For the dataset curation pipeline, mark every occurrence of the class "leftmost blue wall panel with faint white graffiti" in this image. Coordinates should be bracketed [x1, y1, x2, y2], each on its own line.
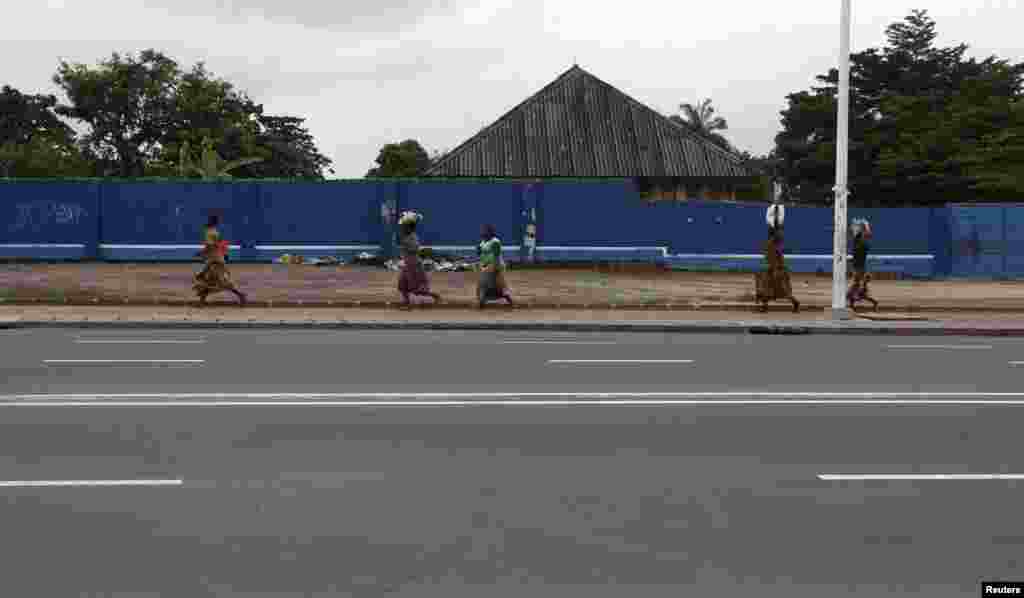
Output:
[0, 182, 99, 259]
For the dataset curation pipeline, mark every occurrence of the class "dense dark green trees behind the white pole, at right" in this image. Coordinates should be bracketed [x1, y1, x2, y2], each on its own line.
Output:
[773, 10, 1024, 205]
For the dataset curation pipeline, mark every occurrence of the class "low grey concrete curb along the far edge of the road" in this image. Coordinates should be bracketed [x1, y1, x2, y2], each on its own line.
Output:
[0, 319, 1024, 337]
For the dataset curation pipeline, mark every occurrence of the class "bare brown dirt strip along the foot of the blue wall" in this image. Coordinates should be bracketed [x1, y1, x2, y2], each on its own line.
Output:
[6, 264, 1024, 317]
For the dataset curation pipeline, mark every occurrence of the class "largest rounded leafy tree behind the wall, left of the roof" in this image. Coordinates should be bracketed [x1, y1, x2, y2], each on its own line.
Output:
[54, 49, 333, 178]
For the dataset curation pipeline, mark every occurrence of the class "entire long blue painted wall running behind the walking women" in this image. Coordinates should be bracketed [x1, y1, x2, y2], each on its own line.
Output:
[0, 180, 1024, 277]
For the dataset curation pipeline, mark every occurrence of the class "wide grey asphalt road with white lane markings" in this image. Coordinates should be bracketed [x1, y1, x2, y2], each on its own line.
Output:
[0, 330, 1024, 598]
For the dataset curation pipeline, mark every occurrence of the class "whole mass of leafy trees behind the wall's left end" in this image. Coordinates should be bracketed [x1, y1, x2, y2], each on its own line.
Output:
[0, 49, 334, 178]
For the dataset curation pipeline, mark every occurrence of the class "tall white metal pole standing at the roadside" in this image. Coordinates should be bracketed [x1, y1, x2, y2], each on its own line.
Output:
[831, 0, 850, 319]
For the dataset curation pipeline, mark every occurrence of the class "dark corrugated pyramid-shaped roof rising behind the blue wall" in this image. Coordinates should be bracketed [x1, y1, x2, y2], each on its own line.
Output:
[426, 67, 752, 178]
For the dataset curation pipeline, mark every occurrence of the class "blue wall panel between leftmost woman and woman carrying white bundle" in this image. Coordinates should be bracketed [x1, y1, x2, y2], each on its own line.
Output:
[254, 181, 387, 261]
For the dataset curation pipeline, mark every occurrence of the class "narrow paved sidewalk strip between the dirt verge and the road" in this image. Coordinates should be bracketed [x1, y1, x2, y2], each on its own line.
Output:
[0, 306, 1024, 336]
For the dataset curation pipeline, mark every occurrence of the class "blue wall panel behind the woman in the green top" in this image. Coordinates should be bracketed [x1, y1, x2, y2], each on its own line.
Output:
[399, 182, 524, 249]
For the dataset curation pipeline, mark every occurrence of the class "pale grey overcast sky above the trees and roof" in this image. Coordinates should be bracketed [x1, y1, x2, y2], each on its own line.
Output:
[0, 0, 1024, 178]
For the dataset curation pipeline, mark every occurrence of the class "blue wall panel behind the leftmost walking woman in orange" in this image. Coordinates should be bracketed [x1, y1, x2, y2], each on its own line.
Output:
[100, 182, 256, 261]
